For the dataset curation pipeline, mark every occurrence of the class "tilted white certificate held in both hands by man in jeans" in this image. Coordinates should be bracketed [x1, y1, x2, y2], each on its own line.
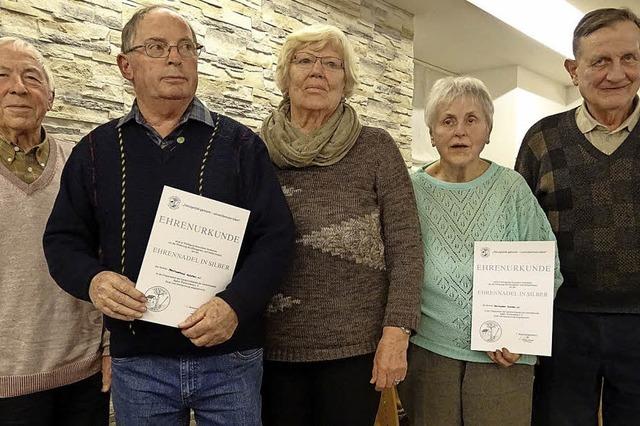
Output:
[136, 186, 249, 327]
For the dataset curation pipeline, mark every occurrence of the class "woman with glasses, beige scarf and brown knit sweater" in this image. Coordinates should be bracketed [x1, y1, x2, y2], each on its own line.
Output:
[262, 25, 422, 426]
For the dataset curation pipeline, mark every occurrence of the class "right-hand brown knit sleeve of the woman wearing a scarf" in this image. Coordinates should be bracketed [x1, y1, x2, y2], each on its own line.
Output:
[376, 131, 424, 330]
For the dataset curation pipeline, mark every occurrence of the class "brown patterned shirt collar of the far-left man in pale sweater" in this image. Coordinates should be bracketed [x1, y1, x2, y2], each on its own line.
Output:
[0, 128, 49, 184]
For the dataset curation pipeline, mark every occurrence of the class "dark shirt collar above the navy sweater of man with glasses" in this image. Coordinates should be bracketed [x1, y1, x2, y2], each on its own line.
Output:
[117, 97, 213, 149]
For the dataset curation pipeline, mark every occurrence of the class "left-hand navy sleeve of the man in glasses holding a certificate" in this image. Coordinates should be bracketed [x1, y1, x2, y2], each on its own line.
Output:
[43, 140, 107, 301]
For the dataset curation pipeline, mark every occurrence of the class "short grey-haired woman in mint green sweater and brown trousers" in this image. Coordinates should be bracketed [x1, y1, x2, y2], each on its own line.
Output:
[399, 77, 562, 426]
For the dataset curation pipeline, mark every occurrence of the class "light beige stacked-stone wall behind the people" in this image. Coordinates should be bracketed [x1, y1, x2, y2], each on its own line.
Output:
[0, 0, 413, 161]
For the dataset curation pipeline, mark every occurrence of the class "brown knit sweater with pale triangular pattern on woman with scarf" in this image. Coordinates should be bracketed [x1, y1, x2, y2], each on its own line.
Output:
[265, 127, 423, 362]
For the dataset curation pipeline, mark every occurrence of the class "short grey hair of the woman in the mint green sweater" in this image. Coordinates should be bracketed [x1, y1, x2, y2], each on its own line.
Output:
[424, 76, 493, 131]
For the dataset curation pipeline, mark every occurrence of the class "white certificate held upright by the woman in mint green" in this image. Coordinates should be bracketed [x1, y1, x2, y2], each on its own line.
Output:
[471, 241, 556, 356]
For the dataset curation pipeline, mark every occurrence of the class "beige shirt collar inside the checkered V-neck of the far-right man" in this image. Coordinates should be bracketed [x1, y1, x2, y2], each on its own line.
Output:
[576, 96, 640, 155]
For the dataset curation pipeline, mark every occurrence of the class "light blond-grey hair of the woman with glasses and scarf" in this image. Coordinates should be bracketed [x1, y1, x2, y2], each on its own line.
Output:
[276, 24, 359, 97]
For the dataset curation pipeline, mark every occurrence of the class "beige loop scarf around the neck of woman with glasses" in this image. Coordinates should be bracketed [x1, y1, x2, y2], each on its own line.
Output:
[261, 98, 362, 168]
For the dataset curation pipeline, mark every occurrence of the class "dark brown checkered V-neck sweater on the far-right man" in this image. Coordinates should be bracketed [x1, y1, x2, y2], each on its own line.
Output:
[515, 109, 640, 314]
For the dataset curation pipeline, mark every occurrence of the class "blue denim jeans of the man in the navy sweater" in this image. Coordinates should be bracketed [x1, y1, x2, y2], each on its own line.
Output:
[111, 349, 262, 426]
